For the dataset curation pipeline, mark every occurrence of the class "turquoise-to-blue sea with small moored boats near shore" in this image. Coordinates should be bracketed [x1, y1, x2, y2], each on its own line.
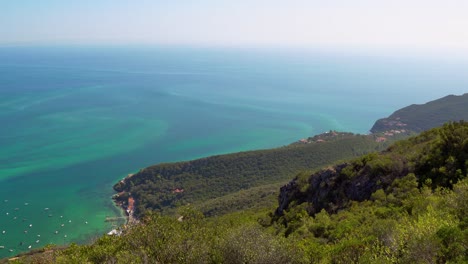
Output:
[0, 47, 468, 258]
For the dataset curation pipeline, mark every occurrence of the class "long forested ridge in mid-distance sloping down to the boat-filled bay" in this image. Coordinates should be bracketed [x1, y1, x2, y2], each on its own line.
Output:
[114, 131, 388, 216]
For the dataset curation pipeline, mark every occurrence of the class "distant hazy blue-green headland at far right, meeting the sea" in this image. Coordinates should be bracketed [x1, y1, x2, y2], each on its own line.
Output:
[371, 93, 468, 133]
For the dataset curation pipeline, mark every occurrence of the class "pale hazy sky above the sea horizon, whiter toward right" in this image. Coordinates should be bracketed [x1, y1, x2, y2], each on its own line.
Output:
[0, 0, 468, 53]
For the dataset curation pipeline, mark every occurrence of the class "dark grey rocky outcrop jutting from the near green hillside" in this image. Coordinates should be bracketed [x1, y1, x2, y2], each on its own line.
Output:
[276, 161, 409, 216]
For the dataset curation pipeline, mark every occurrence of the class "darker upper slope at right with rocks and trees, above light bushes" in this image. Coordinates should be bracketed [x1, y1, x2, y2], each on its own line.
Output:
[276, 121, 468, 218]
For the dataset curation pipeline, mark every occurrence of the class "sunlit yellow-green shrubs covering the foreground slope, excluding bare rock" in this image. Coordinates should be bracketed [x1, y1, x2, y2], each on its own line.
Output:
[9, 122, 468, 263]
